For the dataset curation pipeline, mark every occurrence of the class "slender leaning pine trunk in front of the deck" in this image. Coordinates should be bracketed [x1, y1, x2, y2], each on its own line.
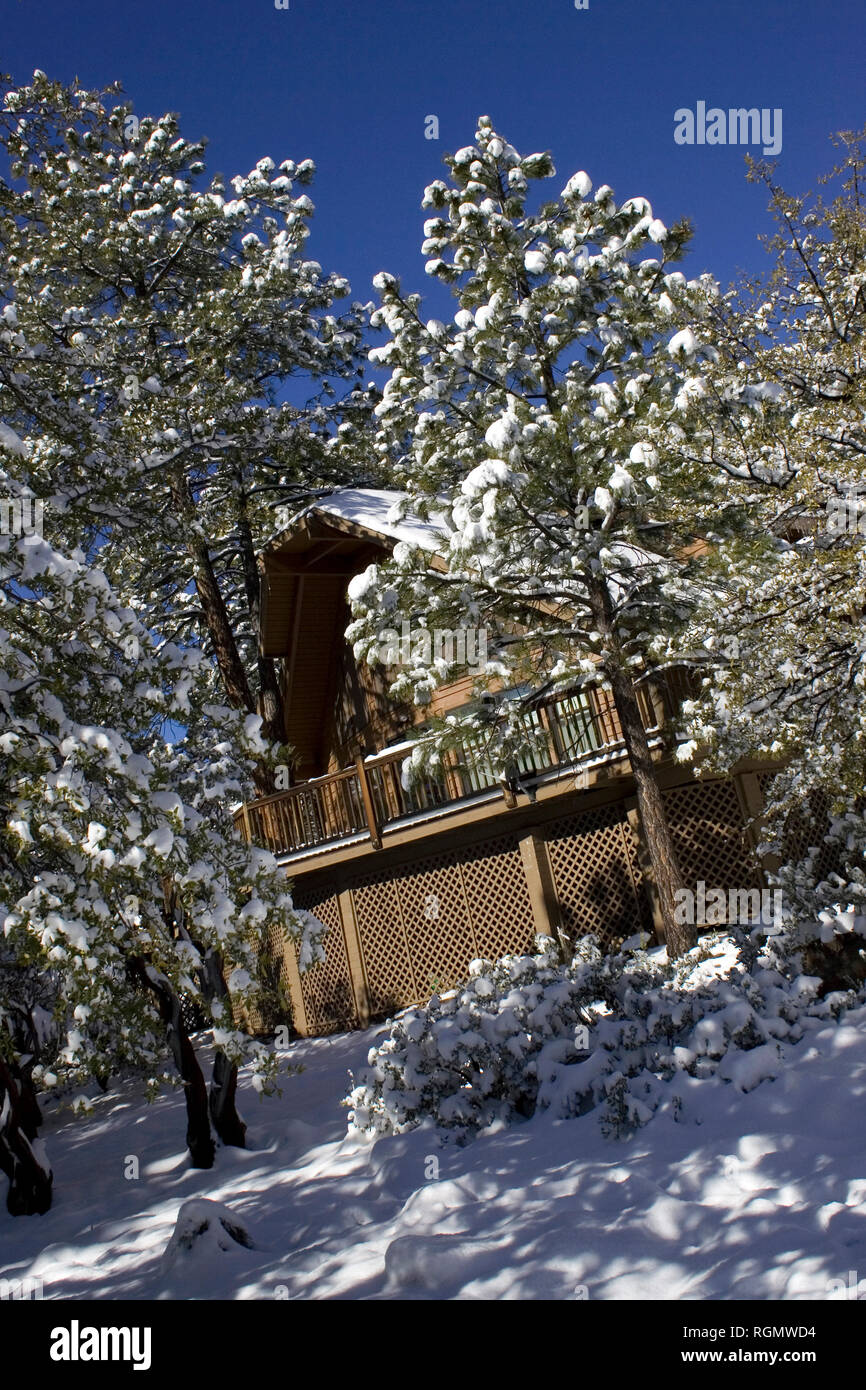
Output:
[589, 584, 695, 958]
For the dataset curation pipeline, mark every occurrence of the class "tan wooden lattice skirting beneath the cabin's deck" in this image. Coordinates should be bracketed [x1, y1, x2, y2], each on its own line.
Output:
[261, 781, 778, 1034]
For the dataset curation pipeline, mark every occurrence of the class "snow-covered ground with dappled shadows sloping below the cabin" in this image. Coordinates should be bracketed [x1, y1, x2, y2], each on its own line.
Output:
[0, 1009, 866, 1300]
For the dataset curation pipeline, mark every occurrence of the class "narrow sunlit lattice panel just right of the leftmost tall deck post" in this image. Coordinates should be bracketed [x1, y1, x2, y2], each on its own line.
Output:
[352, 874, 421, 1013]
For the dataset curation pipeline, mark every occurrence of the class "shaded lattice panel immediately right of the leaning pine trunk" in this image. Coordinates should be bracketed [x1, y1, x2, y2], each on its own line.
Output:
[664, 781, 760, 888]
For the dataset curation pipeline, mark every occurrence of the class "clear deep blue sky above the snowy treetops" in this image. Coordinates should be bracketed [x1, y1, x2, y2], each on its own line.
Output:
[0, 0, 866, 309]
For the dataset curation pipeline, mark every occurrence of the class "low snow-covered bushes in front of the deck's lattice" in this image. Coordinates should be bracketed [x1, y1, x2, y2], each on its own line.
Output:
[345, 917, 866, 1140]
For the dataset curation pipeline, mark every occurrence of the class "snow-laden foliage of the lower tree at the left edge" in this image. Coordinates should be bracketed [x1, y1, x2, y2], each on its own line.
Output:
[0, 511, 321, 1087]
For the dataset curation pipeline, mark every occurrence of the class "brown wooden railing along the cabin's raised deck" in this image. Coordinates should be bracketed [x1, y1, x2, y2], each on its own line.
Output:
[235, 666, 706, 853]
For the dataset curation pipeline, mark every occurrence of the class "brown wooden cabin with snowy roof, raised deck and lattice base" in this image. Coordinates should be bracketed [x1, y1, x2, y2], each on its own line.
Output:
[236, 489, 771, 1034]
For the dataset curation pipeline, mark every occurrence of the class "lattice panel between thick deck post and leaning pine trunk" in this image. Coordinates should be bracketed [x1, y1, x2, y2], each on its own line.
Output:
[548, 805, 652, 947]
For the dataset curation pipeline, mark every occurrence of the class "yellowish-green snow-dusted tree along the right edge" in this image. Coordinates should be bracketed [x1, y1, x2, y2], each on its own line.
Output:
[675, 132, 866, 923]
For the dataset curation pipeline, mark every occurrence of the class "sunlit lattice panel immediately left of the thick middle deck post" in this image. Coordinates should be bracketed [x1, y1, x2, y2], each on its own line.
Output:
[460, 838, 535, 960]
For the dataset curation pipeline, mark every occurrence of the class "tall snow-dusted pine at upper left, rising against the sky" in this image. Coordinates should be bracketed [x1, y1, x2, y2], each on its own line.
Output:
[0, 72, 366, 794]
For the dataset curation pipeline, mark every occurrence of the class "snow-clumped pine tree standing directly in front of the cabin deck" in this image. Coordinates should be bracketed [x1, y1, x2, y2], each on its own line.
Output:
[350, 117, 740, 954]
